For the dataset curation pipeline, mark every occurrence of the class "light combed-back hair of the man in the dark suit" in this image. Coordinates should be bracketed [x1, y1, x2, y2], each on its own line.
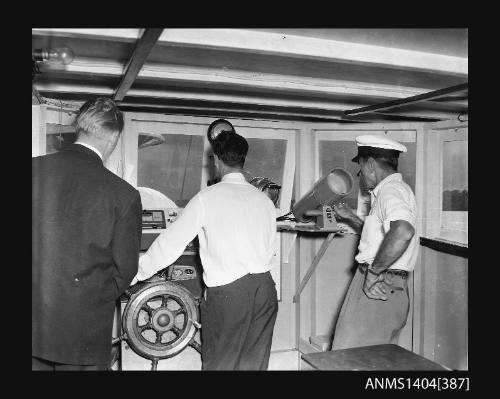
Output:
[73, 97, 123, 137]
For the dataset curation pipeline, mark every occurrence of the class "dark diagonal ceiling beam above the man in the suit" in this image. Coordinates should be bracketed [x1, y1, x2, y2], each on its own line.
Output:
[113, 28, 163, 101]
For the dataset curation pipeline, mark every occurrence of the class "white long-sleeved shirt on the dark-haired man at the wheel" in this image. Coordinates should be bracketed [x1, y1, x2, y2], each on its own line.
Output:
[134, 173, 277, 287]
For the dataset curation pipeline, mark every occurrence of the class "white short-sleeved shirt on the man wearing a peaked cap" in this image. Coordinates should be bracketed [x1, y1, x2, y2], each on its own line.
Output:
[355, 173, 418, 271]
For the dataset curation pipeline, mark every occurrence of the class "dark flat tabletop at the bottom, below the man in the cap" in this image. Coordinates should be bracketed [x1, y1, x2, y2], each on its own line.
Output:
[302, 344, 447, 371]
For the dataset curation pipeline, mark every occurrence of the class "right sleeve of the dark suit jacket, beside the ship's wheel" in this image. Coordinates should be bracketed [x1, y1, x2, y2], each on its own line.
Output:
[112, 191, 142, 298]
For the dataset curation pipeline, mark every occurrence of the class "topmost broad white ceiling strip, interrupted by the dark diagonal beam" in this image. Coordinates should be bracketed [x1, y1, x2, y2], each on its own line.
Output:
[32, 29, 468, 77]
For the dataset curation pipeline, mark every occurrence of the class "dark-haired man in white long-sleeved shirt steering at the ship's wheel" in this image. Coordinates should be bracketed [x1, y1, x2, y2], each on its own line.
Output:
[134, 132, 278, 370]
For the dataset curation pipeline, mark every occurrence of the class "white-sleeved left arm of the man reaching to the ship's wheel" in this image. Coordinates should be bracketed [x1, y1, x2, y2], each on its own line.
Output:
[131, 195, 203, 285]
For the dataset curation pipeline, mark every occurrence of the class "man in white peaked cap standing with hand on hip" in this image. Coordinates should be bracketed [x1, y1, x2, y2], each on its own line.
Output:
[332, 135, 418, 350]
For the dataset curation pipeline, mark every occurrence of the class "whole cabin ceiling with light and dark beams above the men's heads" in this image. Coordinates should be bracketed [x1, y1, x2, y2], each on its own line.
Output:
[32, 29, 468, 122]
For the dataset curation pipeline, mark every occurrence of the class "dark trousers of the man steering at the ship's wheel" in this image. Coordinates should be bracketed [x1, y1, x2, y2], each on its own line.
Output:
[201, 272, 278, 370]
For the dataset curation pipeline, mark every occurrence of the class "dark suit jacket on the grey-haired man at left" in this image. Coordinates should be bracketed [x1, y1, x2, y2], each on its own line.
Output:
[32, 144, 142, 364]
